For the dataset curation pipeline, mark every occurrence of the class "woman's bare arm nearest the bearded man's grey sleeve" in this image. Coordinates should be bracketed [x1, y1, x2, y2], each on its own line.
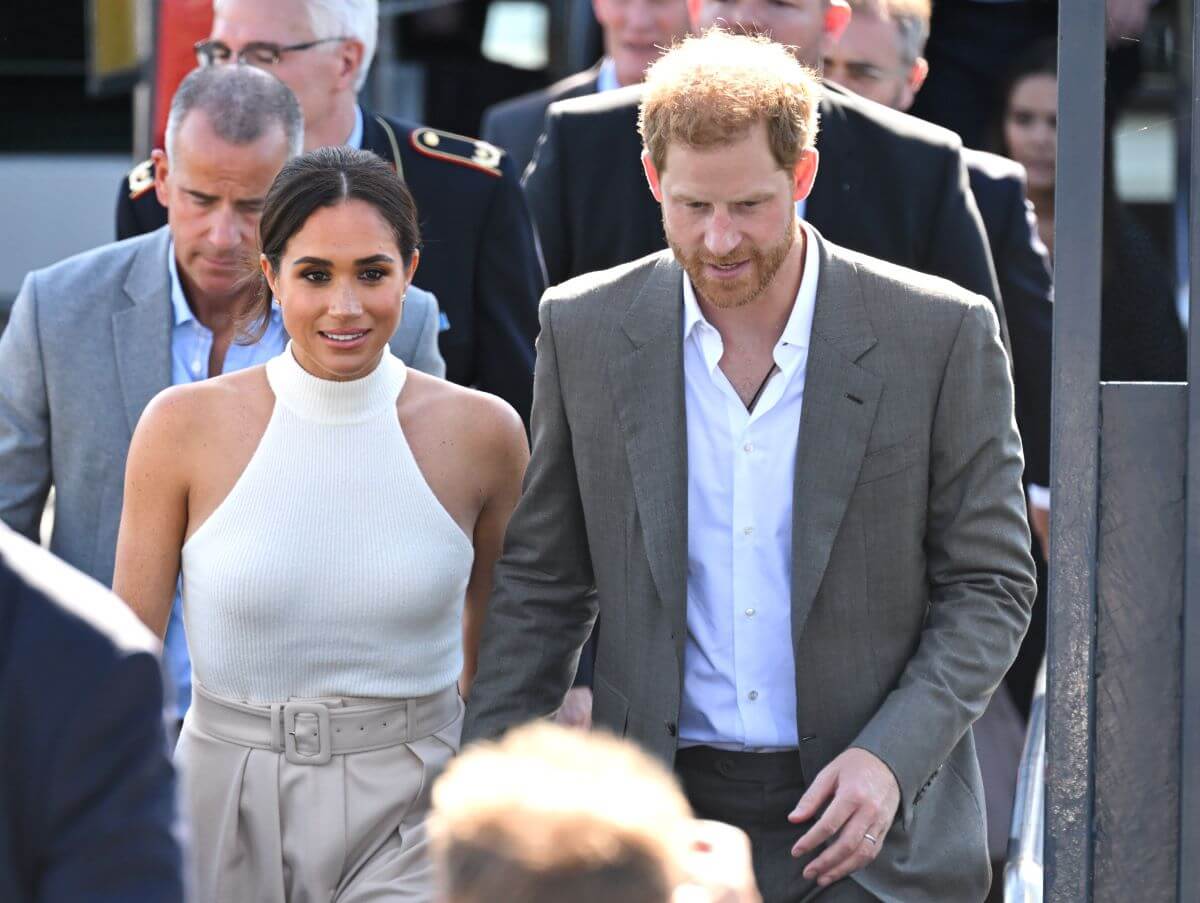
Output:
[458, 400, 529, 699]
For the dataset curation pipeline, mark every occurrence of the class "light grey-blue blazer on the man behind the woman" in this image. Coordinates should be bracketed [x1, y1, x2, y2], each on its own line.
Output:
[0, 226, 445, 585]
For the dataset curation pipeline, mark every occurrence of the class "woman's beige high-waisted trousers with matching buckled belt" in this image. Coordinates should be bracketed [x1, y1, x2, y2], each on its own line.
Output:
[175, 684, 463, 903]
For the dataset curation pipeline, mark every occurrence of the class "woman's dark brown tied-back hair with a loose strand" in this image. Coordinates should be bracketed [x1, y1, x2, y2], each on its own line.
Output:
[240, 146, 421, 342]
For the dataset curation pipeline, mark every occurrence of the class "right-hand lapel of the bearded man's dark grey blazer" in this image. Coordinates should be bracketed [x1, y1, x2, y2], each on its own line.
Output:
[792, 235, 883, 644]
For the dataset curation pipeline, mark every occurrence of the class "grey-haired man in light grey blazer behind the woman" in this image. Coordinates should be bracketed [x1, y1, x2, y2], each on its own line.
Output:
[0, 66, 445, 718]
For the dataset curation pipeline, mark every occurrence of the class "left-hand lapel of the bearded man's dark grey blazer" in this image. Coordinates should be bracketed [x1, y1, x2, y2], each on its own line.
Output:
[608, 251, 688, 662]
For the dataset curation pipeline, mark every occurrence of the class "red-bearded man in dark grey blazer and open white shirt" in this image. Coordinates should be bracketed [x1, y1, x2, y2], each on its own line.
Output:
[464, 30, 1033, 903]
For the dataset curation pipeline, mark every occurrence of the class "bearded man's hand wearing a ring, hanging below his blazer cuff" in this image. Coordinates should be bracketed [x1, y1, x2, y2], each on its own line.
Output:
[787, 748, 900, 887]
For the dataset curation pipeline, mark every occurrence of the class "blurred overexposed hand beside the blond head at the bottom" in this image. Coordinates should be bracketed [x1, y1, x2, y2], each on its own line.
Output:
[672, 819, 762, 903]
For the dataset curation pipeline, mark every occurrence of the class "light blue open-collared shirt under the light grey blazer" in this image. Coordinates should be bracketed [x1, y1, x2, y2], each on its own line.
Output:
[162, 243, 288, 718]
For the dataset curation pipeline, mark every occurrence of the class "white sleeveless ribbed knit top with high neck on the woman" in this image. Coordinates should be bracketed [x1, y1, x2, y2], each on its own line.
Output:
[182, 343, 474, 702]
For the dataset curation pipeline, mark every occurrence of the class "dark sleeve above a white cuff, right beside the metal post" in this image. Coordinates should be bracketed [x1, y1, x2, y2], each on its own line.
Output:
[992, 183, 1054, 486]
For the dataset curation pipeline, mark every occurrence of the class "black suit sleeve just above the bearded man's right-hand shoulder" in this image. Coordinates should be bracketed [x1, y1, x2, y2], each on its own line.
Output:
[917, 149, 1009, 349]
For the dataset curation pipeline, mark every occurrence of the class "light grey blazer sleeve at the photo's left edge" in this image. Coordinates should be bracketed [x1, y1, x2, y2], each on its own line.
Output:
[0, 273, 52, 542]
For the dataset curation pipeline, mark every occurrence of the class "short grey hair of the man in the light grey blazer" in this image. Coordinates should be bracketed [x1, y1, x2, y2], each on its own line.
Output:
[166, 66, 304, 157]
